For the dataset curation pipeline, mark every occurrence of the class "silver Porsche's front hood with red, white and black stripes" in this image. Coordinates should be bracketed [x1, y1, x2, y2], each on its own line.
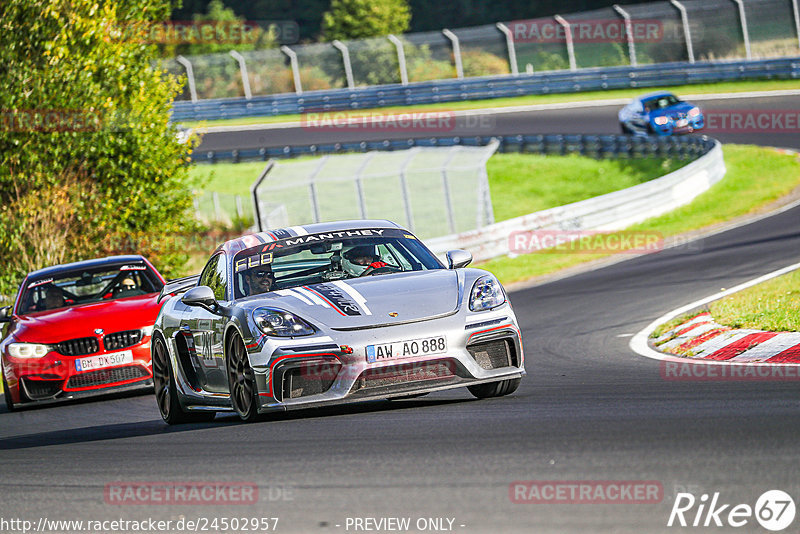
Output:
[243, 269, 461, 329]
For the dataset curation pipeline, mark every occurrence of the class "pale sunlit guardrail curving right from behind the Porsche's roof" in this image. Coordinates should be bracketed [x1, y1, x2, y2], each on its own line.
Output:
[426, 139, 726, 261]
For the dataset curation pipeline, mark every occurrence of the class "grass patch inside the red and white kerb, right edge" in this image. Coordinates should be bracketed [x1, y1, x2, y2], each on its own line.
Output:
[708, 271, 800, 332]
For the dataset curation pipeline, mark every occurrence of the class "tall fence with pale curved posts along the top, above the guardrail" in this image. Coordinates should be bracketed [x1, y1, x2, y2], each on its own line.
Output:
[164, 0, 800, 100]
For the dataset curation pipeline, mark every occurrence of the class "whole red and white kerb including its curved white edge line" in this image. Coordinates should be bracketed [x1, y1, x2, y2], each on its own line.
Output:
[629, 263, 800, 366]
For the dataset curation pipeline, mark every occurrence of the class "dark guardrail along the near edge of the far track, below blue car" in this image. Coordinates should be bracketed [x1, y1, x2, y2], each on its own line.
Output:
[192, 134, 713, 163]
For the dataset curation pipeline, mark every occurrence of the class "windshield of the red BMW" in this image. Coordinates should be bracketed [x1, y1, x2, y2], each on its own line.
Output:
[19, 262, 163, 314]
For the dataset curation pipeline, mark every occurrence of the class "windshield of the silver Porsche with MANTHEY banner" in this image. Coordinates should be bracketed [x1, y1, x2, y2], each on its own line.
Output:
[233, 228, 444, 298]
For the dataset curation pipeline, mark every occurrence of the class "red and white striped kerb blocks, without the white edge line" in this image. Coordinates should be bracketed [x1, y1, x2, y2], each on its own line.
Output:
[654, 312, 800, 363]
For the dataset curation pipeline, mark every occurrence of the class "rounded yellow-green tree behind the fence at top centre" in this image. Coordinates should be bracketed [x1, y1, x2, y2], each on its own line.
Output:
[322, 0, 411, 41]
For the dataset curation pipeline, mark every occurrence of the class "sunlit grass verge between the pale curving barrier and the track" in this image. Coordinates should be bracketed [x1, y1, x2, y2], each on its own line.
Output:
[481, 145, 800, 284]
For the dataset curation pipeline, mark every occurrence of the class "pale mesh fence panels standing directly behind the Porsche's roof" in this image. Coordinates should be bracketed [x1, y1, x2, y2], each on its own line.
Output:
[253, 144, 499, 238]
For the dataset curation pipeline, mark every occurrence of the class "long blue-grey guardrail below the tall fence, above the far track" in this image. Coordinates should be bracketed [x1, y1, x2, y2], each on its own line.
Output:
[172, 57, 800, 122]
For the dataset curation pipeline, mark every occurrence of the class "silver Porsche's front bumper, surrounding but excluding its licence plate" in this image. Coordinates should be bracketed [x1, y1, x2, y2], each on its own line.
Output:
[250, 310, 525, 412]
